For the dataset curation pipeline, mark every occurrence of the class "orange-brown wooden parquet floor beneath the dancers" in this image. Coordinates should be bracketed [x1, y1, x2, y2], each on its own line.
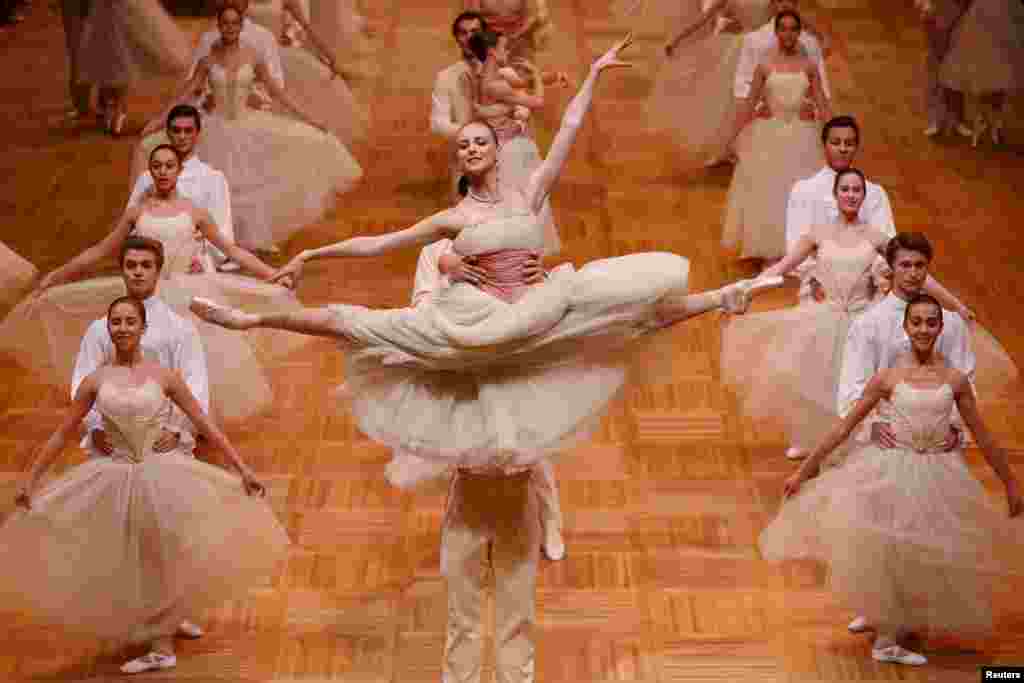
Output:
[0, 0, 1024, 683]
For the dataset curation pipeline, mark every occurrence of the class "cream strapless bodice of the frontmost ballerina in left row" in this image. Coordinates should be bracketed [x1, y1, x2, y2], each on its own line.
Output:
[96, 380, 171, 463]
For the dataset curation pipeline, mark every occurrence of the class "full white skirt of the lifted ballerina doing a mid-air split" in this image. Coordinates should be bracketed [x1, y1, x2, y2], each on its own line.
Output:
[331, 253, 689, 485]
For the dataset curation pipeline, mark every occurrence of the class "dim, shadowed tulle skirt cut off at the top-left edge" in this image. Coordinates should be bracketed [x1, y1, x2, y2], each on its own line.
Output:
[79, 0, 191, 86]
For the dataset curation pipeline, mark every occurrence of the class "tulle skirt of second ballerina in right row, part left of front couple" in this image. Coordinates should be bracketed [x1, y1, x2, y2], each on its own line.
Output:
[722, 303, 855, 447]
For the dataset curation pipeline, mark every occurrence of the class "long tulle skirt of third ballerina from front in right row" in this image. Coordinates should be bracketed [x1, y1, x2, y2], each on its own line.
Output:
[722, 118, 824, 259]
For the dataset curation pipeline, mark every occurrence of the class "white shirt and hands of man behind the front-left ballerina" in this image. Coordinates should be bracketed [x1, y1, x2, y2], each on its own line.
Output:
[71, 294, 210, 456]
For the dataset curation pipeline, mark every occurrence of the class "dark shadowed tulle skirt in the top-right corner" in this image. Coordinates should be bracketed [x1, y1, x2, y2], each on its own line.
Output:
[939, 0, 1024, 95]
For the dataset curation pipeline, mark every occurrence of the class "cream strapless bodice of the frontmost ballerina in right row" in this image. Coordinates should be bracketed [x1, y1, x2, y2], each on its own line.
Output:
[888, 382, 954, 453]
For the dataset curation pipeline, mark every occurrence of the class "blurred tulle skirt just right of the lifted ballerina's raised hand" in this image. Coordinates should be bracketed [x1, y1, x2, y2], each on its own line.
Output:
[648, 34, 743, 163]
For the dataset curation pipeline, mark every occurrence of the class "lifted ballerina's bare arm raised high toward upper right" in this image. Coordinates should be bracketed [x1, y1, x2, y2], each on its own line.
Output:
[525, 33, 633, 213]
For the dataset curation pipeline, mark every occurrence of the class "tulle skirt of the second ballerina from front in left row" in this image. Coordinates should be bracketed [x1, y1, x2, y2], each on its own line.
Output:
[0, 273, 308, 422]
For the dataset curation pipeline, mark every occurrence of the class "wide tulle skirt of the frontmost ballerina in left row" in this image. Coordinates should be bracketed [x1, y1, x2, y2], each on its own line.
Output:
[0, 452, 290, 642]
